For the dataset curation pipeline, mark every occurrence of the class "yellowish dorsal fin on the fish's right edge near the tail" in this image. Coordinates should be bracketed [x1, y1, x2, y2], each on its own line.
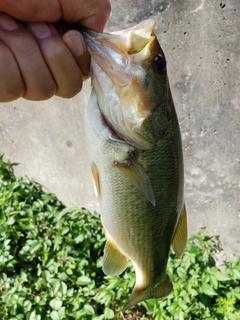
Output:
[172, 205, 187, 257]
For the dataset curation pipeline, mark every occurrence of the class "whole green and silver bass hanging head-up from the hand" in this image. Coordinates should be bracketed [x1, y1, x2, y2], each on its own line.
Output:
[82, 19, 187, 311]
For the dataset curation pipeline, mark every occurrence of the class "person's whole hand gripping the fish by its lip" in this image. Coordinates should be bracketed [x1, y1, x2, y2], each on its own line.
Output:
[0, 0, 110, 102]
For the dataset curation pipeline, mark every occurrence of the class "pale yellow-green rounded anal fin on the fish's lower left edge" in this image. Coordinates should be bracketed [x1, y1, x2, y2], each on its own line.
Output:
[103, 238, 128, 275]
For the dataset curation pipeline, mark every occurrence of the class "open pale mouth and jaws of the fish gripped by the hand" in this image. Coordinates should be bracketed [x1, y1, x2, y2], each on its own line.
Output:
[82, 19, 155, 86]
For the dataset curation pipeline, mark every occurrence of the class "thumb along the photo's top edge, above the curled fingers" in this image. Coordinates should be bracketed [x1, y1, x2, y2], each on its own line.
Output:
[0, 0, 111, 32]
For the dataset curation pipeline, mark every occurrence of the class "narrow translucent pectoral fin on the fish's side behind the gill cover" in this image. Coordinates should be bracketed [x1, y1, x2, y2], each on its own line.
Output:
[115, 154, 156, 206]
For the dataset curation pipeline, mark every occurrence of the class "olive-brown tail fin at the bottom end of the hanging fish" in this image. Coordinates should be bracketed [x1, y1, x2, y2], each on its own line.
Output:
[123, 275, 172, 311]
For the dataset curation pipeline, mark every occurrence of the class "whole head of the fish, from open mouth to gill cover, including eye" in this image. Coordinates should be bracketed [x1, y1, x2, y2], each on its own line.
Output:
[83, 19, 170, 150]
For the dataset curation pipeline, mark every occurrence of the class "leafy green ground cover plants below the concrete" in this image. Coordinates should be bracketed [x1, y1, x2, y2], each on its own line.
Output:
[0, 158, 240, 320]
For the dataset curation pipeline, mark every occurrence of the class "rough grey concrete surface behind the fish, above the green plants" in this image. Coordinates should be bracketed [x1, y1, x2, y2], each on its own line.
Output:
[0, 0, 240, 258]
